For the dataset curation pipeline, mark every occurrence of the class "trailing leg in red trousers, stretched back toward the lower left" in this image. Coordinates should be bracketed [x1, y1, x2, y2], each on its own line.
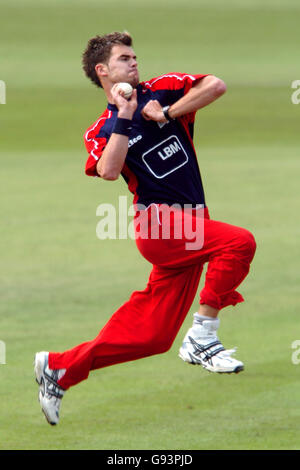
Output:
[45, 264, 202, 390]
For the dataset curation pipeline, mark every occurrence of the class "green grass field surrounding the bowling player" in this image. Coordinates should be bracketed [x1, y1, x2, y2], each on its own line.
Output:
[0, 0, 300, 450]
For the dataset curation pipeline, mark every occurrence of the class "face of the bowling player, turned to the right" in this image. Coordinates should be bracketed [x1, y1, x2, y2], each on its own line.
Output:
[105, 44, 139, 87]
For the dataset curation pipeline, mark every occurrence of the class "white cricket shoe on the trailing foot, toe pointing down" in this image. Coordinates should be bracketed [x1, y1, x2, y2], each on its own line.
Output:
[34, 351, 66, 425]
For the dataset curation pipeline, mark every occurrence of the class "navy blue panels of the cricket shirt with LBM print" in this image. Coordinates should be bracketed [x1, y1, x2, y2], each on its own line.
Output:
[96, 85, 205, 206]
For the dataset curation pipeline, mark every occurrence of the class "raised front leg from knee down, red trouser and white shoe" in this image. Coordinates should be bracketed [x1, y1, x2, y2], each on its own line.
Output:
[179, 222, 256, 373]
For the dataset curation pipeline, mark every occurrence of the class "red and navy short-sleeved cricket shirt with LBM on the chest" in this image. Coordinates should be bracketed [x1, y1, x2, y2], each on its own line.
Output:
[84, 73, 206, 207]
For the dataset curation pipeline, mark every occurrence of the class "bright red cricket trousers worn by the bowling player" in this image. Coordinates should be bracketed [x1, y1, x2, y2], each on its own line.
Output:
[49, 205, 256, 390]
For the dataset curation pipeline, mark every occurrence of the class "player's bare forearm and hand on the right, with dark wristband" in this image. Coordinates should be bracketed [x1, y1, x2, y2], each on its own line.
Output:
[142, 75, 226, 122]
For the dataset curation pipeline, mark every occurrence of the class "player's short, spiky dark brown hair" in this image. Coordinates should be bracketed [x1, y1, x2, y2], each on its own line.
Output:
[82, 32, 132, 88]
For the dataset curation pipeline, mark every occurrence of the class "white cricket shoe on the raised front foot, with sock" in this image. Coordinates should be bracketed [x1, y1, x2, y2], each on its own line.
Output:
[179, 319, 244, 374]
